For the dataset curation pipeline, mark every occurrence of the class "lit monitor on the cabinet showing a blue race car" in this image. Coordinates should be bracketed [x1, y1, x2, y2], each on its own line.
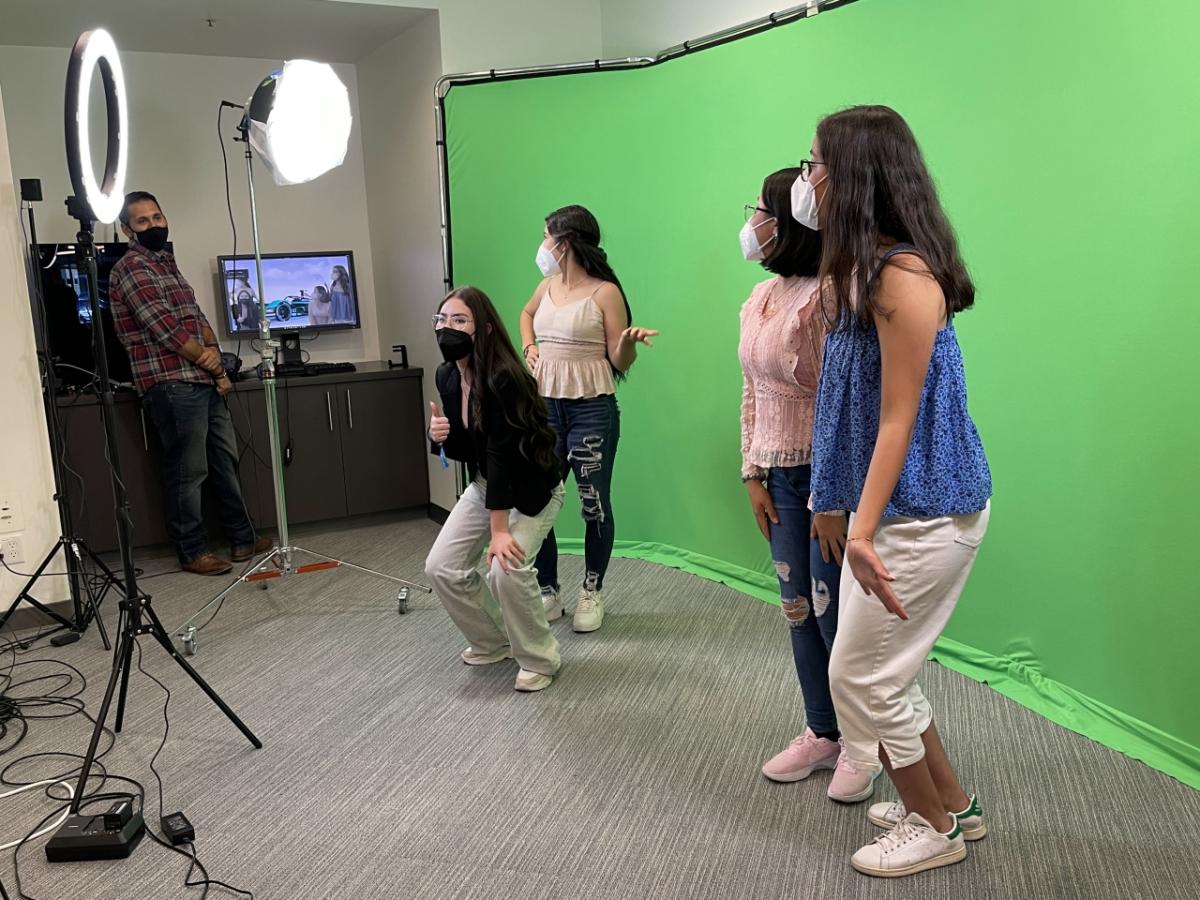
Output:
[217, 250, 362, 337]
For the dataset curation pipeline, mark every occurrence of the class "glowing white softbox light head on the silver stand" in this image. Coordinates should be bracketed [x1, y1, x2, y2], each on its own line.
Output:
[246, 59, 352, 185]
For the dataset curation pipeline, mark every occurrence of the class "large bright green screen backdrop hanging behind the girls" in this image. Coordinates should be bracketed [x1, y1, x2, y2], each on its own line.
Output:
[445, 0, 1200, 786]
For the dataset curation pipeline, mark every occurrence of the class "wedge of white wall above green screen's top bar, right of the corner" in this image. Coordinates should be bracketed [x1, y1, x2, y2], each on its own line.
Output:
[600, 0, 799, 58]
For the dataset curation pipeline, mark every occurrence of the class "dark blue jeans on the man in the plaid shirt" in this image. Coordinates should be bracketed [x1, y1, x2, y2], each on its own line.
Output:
[142, 382, 256, 563]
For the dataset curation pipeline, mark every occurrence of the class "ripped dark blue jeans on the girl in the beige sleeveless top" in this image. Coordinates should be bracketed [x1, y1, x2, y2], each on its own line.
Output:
[534, 394, 620, 590]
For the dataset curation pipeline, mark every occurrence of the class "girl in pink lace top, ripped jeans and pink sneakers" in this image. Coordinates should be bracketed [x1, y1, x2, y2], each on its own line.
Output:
[738, 169, 872, 802]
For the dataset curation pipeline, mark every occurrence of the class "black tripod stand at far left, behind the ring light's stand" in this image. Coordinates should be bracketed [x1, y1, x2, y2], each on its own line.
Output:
[0, 180, 114, 650]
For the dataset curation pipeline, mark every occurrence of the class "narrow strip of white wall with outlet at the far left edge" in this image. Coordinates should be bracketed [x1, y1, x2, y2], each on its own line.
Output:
[0, 84, 68, 610]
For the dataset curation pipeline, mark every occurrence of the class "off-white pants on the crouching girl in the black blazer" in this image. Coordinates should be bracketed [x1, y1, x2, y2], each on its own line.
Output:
[425, 480, 563, 676]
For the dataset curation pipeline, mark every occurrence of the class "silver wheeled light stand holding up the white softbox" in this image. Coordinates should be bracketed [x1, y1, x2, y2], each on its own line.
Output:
[176, 109, 433, 655]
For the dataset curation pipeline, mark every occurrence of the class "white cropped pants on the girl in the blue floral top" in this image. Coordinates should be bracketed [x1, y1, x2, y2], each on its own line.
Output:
[829, 503, 991, 769]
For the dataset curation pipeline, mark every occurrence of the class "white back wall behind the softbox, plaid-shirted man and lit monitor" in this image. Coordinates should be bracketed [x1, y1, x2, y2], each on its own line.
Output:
[0, 47, 379, 364]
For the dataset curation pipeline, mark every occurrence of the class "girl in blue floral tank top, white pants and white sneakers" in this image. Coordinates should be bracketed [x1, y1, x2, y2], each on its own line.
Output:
[792, 107, 991, 877]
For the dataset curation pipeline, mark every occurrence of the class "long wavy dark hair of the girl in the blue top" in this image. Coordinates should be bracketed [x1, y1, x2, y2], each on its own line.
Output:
[810, 106, 974, 328]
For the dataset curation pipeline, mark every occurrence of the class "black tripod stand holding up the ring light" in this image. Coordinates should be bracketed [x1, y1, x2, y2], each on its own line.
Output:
[46, 197, 263, 862]
